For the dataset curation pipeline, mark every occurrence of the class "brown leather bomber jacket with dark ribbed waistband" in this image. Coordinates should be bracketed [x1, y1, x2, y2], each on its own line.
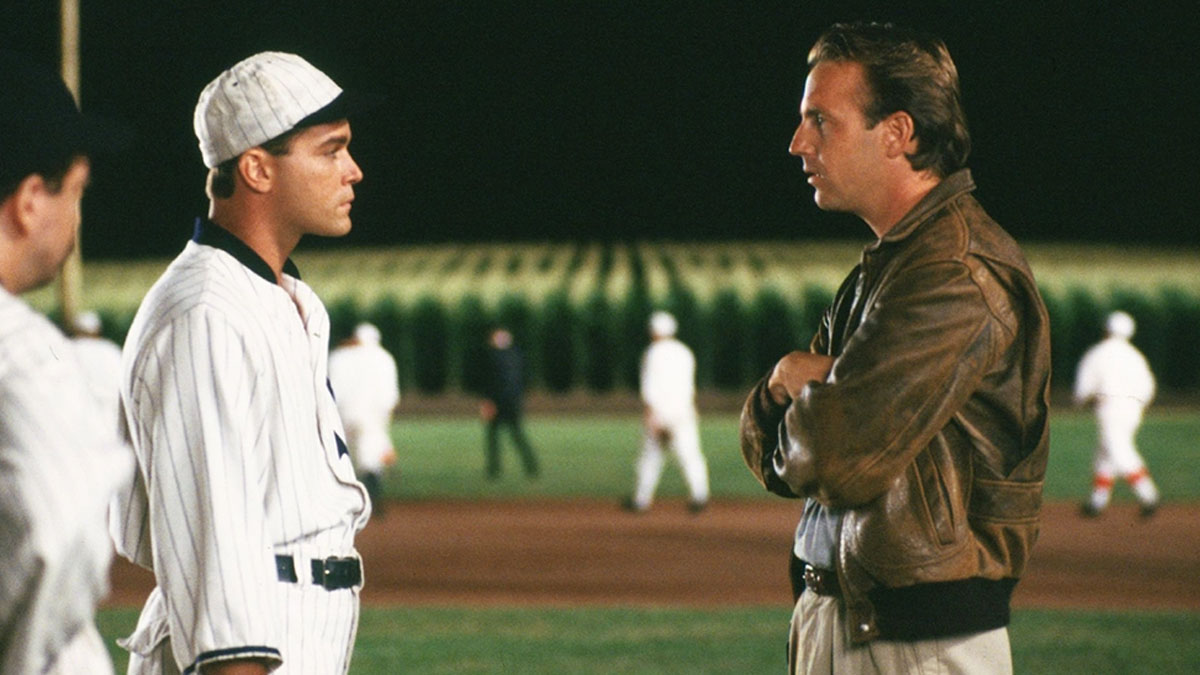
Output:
[740, 169, 1050, 643]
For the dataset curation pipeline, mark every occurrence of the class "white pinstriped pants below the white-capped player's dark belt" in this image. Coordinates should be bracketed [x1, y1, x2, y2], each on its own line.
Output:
[127, 581, 359, 675]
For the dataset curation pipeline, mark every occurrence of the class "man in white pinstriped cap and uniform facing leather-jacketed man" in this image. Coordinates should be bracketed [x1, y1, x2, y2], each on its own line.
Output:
[110, 52, 371, 675]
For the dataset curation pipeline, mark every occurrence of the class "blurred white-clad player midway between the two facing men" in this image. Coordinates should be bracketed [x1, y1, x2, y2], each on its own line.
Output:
[625, 311, 708, 513]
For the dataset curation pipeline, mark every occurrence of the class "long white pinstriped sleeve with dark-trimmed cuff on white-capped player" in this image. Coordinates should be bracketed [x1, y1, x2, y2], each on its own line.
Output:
[131, 309, 281, 669]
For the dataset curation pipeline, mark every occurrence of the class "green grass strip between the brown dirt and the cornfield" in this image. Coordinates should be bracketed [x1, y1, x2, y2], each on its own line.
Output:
[385, 408, 1200, 501]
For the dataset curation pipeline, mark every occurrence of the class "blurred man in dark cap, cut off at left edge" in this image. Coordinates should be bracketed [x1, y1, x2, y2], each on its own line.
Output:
[0, 53, 132, 674]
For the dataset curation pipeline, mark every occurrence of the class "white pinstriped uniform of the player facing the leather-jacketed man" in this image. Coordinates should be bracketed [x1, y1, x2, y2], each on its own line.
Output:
[113, 222, 370, 675]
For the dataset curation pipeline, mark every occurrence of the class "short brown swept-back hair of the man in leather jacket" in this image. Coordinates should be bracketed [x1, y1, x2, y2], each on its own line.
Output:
[809, 22, 971, 178]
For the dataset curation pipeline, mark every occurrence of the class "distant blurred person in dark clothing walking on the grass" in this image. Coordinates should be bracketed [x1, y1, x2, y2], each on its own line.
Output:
[480, 328, 539, 479]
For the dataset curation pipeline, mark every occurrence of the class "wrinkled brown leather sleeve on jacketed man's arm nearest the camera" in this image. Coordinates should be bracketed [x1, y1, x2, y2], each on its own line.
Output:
[777, 257, 1002, 508]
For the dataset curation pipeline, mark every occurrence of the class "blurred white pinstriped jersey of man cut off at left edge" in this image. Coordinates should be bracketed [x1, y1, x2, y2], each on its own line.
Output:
[0, 288, 132, 673]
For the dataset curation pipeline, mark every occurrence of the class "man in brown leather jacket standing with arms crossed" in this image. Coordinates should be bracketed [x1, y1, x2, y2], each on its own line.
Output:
[740, 24, 1050, 673]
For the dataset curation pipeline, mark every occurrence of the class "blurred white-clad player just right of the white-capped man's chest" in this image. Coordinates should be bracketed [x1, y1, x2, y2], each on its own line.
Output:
[329, 323, 400, 510]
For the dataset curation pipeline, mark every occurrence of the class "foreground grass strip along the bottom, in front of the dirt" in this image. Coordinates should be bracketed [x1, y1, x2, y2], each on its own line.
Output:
[100, 607, 1200, 675]
